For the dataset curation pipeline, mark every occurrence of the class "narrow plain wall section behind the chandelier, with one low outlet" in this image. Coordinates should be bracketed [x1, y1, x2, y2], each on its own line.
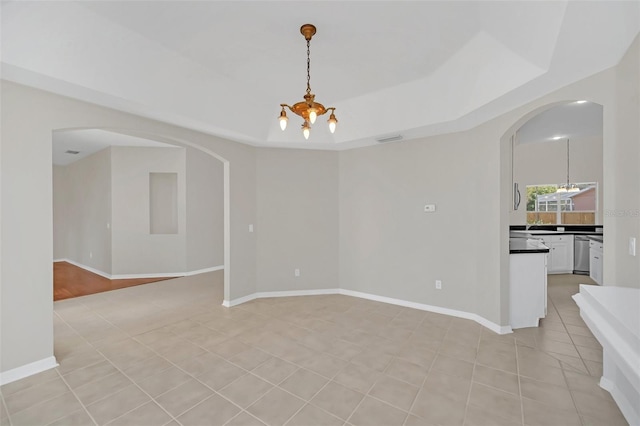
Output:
[255, 149, 339, 291]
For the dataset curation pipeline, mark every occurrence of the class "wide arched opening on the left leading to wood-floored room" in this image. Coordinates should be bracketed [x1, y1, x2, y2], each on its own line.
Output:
[53, 128, 230, 298]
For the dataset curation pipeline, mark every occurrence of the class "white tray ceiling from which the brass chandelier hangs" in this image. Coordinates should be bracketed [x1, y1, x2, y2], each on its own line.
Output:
[2, 0, 640, 149]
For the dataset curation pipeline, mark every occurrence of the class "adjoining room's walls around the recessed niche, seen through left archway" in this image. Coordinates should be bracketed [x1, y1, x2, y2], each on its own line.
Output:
[53, 143, 224, 275]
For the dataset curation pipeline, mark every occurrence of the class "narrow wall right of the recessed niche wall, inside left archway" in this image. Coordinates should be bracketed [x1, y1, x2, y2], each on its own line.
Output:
[186, 148, 224, 271]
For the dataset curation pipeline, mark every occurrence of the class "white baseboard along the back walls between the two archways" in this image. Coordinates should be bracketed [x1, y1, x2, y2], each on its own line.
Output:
[222, 288, 513, 334]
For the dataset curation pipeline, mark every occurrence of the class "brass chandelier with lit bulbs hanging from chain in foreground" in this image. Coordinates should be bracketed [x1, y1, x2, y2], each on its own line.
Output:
[278, 24, 338, 139]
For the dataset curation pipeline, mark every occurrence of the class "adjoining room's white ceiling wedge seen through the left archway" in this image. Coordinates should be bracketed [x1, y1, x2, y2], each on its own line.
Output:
[53, 129, 177, 166]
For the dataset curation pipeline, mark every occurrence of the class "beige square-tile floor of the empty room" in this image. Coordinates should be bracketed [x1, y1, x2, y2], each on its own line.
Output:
[0, 273, 626, 426]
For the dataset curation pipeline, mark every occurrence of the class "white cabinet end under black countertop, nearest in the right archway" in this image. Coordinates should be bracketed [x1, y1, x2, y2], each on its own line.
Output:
[509, 253, 547, 329]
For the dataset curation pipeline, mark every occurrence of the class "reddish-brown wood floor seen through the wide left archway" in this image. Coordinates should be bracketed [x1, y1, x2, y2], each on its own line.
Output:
[53, 262, 176, 301]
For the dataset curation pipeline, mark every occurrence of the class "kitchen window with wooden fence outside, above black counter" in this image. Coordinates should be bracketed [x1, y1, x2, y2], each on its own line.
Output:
[527, 182, 598, 225]
